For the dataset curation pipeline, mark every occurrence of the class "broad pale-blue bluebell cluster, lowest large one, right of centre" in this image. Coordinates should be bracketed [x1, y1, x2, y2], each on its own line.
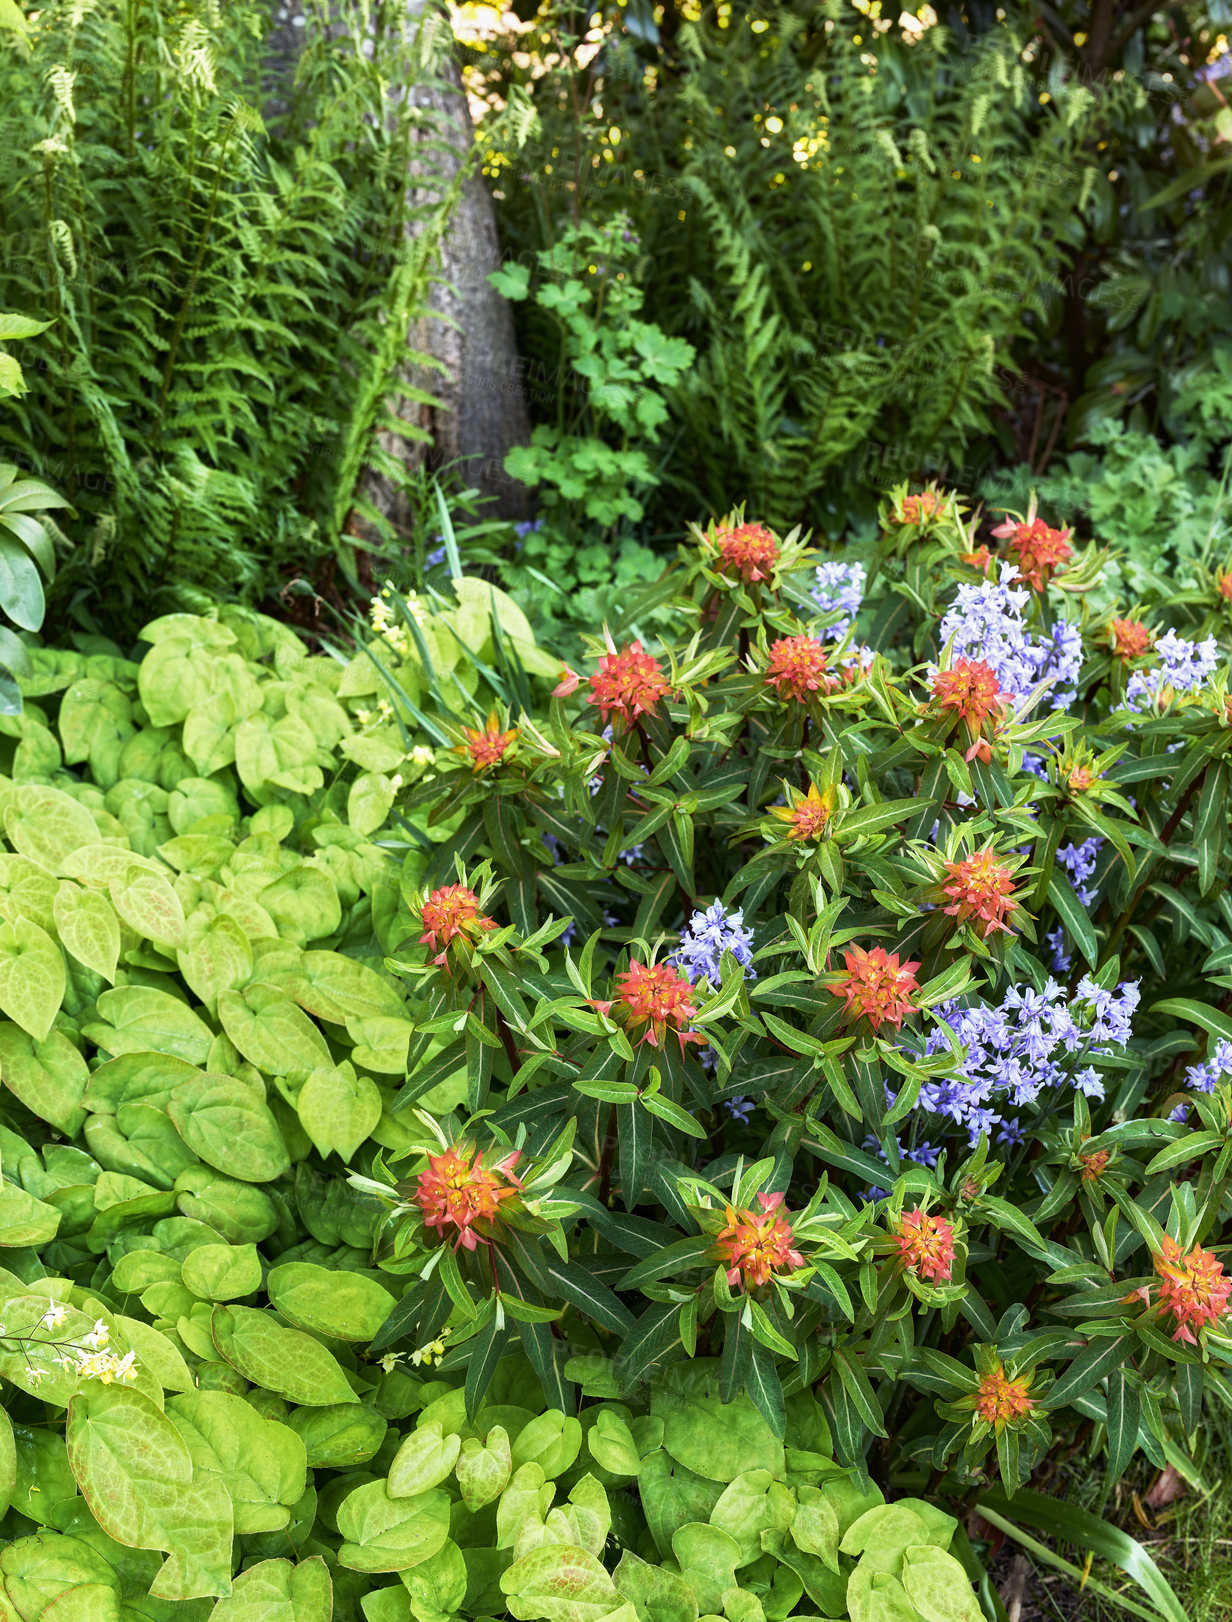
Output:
[919, 975, 1138, 1145]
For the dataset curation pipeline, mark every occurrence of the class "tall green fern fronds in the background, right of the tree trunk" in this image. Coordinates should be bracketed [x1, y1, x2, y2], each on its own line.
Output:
[473, 6, 1108, 530]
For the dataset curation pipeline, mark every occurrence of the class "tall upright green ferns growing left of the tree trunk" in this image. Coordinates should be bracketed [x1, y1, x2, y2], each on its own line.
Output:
[0, 0, 460, 634]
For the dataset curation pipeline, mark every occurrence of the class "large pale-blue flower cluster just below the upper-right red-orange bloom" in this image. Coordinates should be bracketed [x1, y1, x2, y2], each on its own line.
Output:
[940, 564, 1083, 709]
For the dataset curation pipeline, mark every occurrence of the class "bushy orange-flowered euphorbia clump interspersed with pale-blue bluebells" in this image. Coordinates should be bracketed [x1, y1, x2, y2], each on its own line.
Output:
[360, 488, 1232, 1518]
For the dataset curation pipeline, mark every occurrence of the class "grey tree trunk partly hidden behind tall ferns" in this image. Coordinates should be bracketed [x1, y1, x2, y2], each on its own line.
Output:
[266, 0, 530, 530]
